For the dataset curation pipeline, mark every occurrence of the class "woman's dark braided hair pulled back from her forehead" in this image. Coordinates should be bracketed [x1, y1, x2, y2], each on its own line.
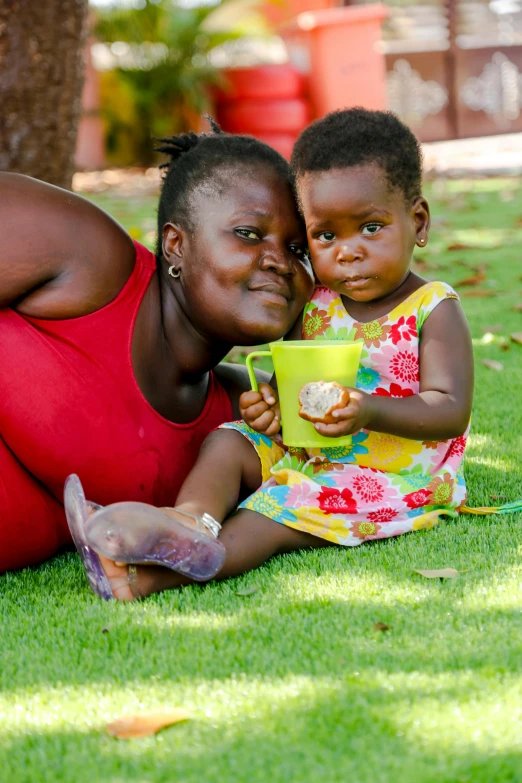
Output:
[155, 117, 292, 262]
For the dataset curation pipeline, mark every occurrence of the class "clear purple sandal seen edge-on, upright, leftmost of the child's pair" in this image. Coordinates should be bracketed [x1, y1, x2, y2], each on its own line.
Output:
[64, 474, 114, 601]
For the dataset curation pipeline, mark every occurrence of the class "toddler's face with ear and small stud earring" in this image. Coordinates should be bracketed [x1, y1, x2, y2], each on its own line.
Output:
[298, 163, 429, 302]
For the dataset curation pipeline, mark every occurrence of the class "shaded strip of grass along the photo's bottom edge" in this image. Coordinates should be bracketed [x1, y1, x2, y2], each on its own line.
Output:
[0, 680, 522, 783]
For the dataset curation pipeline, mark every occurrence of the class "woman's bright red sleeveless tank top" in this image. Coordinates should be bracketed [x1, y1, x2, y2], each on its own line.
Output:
[0, 243, 232, 506]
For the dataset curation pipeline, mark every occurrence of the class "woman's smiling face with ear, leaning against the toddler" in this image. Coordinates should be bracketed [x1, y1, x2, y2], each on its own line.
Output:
[163, 165, 313, 345]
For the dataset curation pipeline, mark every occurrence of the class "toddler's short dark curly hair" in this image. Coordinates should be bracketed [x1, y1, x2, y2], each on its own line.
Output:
[291, 107, 422, 201]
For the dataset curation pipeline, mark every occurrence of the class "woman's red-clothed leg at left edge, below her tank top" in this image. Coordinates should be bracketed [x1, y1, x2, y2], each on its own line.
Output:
[0, 438, 70, 573]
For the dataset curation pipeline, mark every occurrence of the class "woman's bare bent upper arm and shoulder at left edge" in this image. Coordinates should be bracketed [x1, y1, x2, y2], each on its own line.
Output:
[0, 172, 135, 318]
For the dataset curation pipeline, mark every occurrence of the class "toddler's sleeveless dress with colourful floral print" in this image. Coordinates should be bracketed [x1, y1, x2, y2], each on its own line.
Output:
[222, 282, 467, 546]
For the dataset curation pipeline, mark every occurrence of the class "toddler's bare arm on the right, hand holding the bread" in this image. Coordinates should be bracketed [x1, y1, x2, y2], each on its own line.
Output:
[316, 299, 473, 441]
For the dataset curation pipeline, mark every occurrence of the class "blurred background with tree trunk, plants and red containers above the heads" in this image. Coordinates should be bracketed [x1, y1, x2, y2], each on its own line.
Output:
[0, 0, 522, 187]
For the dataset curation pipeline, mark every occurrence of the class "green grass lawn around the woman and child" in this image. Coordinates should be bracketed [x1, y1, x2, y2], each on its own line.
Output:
[0, 180, 522, 783]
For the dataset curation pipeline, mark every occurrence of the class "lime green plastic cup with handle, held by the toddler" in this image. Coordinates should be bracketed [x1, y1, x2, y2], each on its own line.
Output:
[246, 340, 363, 448]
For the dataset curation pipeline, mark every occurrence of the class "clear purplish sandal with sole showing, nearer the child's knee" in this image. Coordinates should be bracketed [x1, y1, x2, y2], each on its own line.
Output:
[85, 502, 225, 582]
